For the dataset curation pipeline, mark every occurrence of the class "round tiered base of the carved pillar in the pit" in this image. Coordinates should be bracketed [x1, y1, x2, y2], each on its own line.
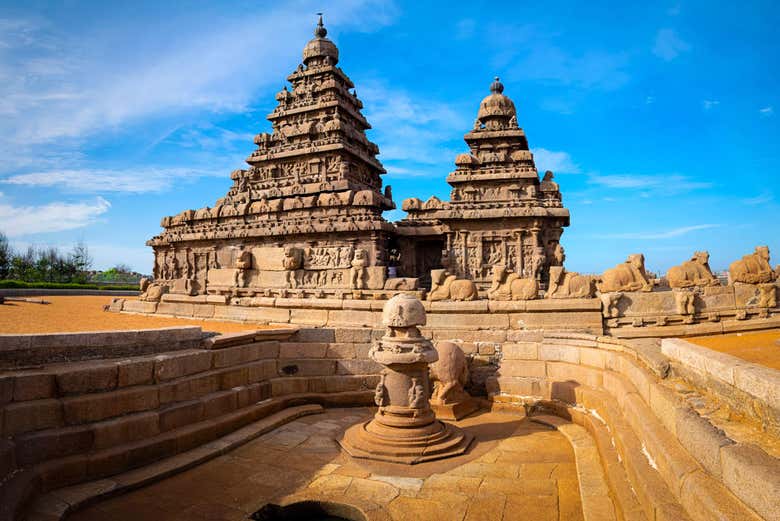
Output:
[339, 411, 474, 465]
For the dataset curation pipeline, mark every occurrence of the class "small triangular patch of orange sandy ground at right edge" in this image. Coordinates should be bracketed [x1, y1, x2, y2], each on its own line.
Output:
[685, 329, 780, 369]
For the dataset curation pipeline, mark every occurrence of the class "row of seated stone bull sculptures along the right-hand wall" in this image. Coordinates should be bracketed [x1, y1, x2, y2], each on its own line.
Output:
[428, 245, 780, 307]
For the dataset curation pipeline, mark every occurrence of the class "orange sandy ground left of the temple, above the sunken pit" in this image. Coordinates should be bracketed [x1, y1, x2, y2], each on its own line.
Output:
[0, 296, 262, 334]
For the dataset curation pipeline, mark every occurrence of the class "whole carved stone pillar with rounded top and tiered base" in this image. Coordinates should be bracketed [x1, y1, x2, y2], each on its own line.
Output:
[340, 294, 473, 464]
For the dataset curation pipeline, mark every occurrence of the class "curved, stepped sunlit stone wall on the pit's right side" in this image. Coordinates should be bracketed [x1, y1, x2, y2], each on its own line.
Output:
[487, 332, 780, 521]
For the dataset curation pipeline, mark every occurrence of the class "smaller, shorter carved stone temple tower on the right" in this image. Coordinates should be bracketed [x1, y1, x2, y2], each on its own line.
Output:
[397, 78, 569, 287]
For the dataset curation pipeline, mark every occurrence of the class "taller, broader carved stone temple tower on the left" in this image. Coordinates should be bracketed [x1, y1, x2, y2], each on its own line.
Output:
[147, 16, 395, 295]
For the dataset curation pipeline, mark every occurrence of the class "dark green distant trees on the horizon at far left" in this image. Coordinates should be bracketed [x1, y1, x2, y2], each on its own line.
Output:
[0, 232, 92, 283]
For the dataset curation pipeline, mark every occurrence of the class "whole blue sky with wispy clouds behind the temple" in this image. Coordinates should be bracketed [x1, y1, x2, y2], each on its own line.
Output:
[0, 0, 780, 272]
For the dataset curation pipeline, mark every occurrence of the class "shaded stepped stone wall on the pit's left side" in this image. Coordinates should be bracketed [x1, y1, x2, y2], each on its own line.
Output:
[0, 328, 377, 520]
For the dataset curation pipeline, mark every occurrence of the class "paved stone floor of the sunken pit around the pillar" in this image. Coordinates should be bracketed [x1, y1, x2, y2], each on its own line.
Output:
[68, 408, 582, 521]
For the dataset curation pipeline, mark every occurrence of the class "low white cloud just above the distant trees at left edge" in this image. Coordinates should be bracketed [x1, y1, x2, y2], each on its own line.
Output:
[0, 197, 111, 237]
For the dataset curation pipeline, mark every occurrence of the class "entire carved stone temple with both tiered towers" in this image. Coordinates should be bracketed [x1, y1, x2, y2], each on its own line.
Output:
[148, 15, 569, 297]
